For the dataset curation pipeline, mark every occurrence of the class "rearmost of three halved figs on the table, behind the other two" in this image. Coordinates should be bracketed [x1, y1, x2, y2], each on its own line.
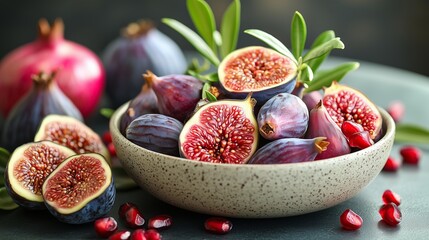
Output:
[34, 114, 110, 162]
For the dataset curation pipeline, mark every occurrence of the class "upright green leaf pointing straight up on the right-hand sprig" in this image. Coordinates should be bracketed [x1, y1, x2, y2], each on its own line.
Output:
[290, 11, 307, 59]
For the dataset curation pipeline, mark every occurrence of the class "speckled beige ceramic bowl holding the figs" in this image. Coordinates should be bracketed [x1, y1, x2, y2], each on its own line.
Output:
[110, 105, 395, 218]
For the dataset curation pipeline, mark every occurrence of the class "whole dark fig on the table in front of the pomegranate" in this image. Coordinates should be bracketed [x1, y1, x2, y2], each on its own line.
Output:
[1, 72, 83, 151]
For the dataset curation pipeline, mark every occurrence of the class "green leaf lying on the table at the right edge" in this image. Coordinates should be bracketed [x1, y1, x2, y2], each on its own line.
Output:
[395, 124, 429, 144]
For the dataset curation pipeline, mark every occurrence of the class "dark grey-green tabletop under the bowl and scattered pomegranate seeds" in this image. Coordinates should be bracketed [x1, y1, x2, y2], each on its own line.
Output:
[0, 58, 429, 239]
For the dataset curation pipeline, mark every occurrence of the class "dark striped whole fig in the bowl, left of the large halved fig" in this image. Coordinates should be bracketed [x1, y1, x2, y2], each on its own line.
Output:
[125, 114, 183, 156]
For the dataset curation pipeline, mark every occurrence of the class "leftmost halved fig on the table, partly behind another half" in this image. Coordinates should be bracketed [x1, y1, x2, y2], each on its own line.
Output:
[5, 141, 76, 209]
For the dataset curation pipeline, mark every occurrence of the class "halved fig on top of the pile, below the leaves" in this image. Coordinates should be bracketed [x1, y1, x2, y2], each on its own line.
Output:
[218, 46, 298, 106]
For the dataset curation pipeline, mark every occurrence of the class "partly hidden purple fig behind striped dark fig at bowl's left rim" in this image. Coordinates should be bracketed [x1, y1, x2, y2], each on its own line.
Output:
[119, 84, 159, 136]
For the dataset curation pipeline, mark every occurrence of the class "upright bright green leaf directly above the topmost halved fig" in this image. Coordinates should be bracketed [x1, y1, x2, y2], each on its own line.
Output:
[220, 0, 241, 58]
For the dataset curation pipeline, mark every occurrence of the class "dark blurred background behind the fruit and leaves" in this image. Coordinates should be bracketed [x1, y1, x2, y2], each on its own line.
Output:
[0, 0, 429, 75]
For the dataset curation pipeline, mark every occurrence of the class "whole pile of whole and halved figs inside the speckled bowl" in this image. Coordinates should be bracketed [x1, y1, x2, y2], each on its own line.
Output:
[120, 47, 382, 164]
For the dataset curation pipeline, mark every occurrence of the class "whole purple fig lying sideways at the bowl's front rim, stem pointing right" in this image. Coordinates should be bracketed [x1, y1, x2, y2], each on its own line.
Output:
[248, 137, 329, 164]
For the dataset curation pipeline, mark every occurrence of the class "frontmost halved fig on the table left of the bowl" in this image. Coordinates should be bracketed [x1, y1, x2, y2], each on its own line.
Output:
[42, 153, 116, 224]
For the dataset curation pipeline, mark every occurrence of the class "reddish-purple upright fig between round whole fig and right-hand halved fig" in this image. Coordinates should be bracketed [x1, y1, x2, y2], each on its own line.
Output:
[305, 101, 351, 160]
